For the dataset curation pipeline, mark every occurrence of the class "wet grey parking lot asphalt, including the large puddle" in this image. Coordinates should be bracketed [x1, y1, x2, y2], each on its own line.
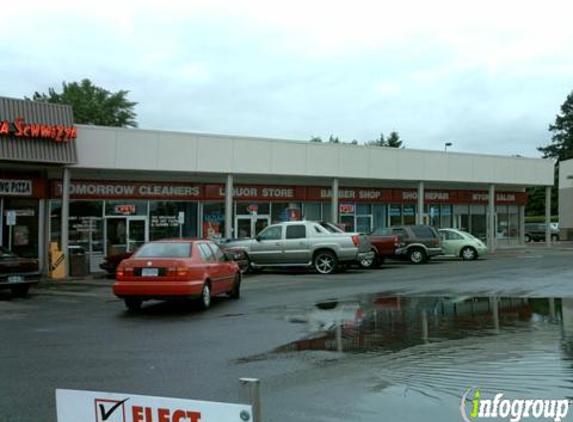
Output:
[0, 246, 573, 422]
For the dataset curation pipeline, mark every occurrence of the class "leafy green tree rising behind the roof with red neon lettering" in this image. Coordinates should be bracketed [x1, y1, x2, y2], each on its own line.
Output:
[30, 79, 137, 127]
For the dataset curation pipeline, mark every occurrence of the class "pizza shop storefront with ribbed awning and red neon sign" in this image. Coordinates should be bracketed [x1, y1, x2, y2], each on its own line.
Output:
[0, 97, 77, 270]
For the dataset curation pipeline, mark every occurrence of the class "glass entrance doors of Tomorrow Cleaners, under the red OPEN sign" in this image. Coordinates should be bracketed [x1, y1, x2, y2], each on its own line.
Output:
[105, 217, 149, 255]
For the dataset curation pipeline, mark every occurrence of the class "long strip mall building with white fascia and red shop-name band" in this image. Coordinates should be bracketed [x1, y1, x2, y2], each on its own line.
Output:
[0, 98, 554, 271]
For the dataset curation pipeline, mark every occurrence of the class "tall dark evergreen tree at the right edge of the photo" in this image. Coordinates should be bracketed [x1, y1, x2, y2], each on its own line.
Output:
[537, 91, 573, 162]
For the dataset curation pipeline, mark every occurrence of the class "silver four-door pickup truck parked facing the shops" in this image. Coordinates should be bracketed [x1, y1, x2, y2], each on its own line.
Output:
[223, 221, 373, 274]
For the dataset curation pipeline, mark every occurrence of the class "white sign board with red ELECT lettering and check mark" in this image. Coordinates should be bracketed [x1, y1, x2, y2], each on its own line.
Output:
[56, 389, 252, 422]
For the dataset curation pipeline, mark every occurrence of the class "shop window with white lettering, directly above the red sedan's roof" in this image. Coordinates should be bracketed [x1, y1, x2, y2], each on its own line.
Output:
[149, 201, 198, 240]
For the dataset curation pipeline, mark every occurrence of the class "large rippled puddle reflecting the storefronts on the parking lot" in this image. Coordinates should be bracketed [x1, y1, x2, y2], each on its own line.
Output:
[267, 296, 573, 398]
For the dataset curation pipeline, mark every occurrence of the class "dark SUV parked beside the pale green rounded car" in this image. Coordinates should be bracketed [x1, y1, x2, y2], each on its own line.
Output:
[377, 225, 444, 264]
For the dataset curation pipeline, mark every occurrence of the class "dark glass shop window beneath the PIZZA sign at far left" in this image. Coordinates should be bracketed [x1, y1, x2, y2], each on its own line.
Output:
[2, 198, 39, 258]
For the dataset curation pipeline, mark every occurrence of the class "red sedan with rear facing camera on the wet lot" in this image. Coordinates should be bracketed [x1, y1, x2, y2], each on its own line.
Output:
[113, 239, 241, 311]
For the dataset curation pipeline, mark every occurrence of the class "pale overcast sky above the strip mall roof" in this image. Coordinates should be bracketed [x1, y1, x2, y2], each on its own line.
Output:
[0, 0, 573, 156]
